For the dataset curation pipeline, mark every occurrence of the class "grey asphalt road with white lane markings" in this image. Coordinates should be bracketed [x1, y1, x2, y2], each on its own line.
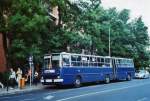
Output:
[0, 79, 150, 101]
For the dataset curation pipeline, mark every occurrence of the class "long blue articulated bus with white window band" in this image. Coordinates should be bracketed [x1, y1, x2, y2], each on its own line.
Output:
[41, 52, 135, 87]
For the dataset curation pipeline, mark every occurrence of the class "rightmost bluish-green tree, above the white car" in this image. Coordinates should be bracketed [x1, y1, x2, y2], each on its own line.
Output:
[130, 17, 150, 67]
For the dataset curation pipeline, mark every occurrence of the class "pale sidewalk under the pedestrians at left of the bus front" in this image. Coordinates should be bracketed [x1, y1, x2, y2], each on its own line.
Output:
[0, 83, 44, 96]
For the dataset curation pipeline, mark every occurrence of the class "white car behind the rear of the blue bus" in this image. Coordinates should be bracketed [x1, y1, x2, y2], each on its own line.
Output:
[135, 70, 150, 79]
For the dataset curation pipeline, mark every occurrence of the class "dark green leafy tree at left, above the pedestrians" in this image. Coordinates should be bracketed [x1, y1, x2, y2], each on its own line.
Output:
[8, 0, 53, 65]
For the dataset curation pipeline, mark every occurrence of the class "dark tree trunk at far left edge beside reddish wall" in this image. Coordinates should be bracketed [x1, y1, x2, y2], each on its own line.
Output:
[0, 0, 12, 67]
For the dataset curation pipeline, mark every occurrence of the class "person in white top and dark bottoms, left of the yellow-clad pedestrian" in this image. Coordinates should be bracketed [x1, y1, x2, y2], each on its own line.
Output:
[9, 68, 16, 89]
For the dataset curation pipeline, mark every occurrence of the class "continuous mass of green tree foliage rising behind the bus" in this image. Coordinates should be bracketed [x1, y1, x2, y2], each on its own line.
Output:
[0, 0, 150, 67]
